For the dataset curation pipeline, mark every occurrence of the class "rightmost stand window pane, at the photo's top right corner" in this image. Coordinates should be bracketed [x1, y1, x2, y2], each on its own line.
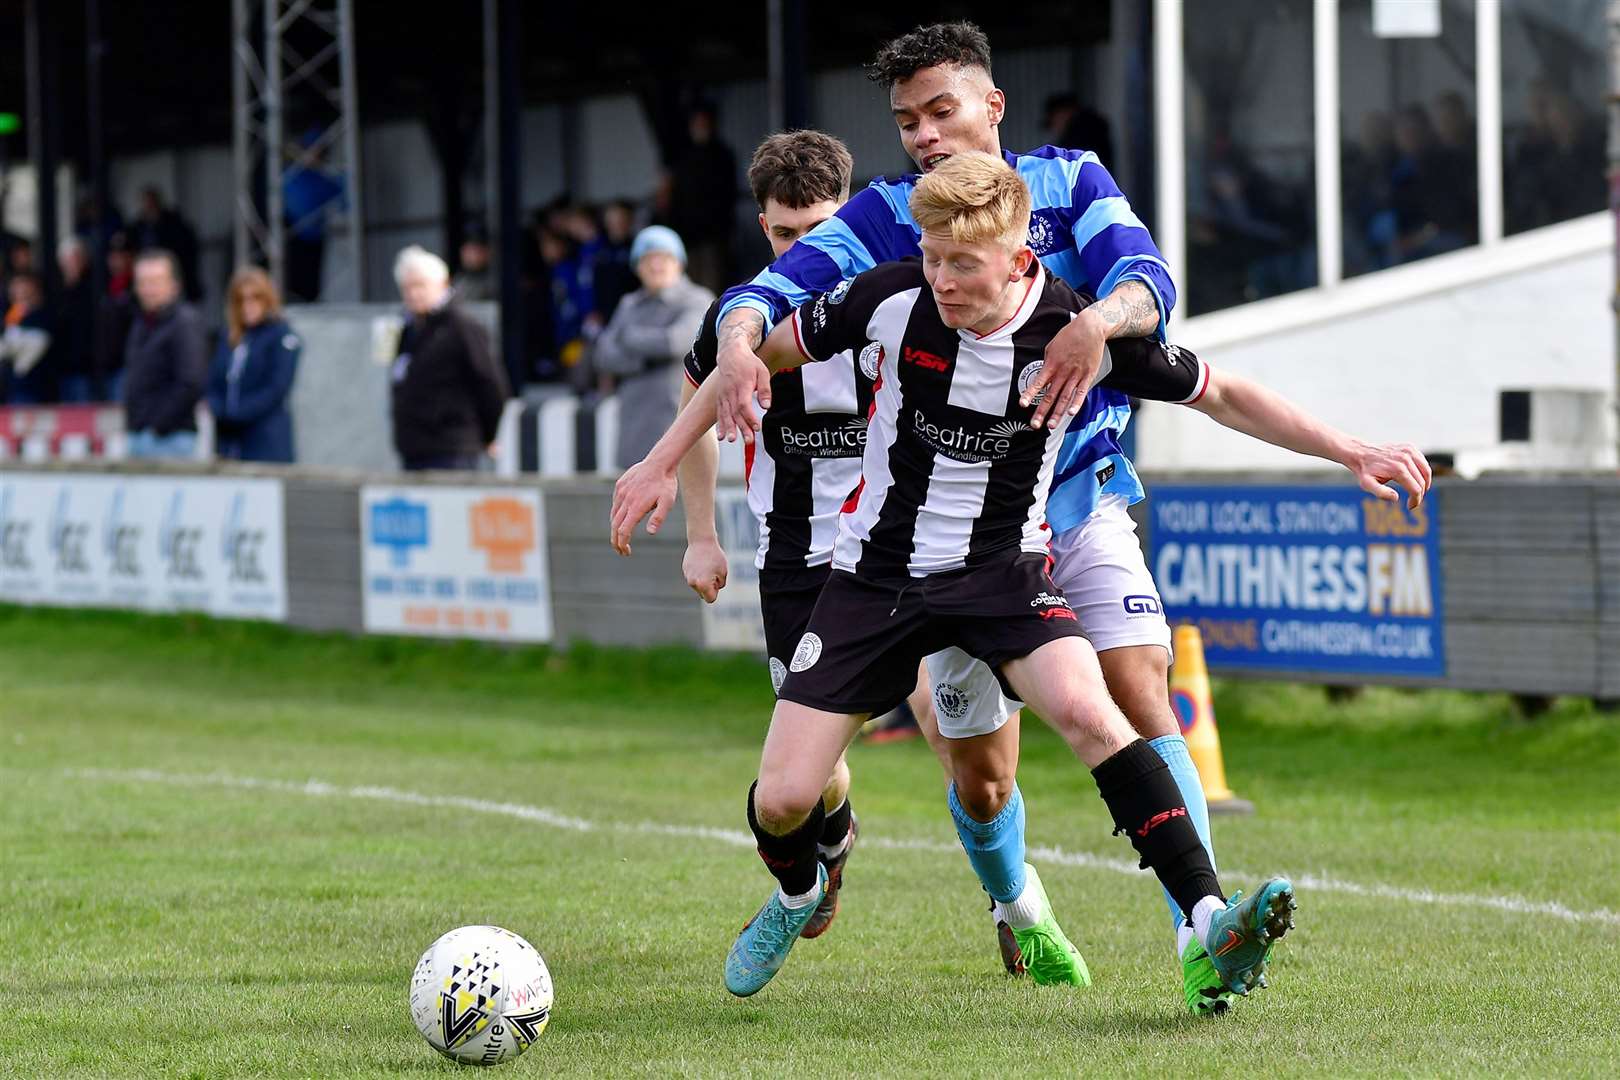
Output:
[1502, 0, 1607, 233]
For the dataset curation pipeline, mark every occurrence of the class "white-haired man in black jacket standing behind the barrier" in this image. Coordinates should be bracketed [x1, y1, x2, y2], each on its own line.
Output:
[392, 244, 509, 471]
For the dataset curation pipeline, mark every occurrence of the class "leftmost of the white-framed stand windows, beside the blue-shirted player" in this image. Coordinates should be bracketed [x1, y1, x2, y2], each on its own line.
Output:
[1181, 0, 1317, 314]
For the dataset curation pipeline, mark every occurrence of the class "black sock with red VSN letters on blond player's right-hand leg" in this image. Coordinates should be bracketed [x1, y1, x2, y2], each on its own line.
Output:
[1092, 738, 1225, 918]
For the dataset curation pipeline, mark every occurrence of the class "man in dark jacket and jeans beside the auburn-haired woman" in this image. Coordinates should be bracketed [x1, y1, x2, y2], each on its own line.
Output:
[123, 249, 207, 458]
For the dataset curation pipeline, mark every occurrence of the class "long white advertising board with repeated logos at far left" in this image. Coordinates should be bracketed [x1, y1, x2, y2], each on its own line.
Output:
[0, 473, 287, 622]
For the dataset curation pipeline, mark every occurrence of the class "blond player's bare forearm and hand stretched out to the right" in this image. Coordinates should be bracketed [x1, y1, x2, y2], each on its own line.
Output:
[1191, 368, 1434, 508]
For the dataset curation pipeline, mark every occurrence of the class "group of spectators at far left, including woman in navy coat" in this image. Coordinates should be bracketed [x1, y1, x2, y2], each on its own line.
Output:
[0, 188, 301, 461]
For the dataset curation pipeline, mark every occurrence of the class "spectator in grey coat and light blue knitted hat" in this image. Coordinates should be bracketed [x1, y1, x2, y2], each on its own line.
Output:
[591, 225, 714, 468]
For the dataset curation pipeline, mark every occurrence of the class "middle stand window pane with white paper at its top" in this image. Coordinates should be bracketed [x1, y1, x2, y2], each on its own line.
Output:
[1338, 0, 1483, 277]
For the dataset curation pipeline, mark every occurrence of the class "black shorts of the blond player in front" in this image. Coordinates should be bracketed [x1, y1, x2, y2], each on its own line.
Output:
[778, 552, 1081, 714]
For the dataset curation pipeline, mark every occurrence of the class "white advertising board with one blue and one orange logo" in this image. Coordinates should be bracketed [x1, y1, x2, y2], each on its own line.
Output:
[360, 486, 551, 641]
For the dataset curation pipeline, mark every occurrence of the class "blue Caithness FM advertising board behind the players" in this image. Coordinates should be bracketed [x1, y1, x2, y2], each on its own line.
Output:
[1149, 484, 1445, 677]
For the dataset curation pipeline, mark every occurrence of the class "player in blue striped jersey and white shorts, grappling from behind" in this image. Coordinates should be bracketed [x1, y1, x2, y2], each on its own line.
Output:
[693, 23, 1419, 1012]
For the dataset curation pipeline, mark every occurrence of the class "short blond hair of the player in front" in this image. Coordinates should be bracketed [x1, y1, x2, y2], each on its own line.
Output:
[910, 151, 1030, 248]
